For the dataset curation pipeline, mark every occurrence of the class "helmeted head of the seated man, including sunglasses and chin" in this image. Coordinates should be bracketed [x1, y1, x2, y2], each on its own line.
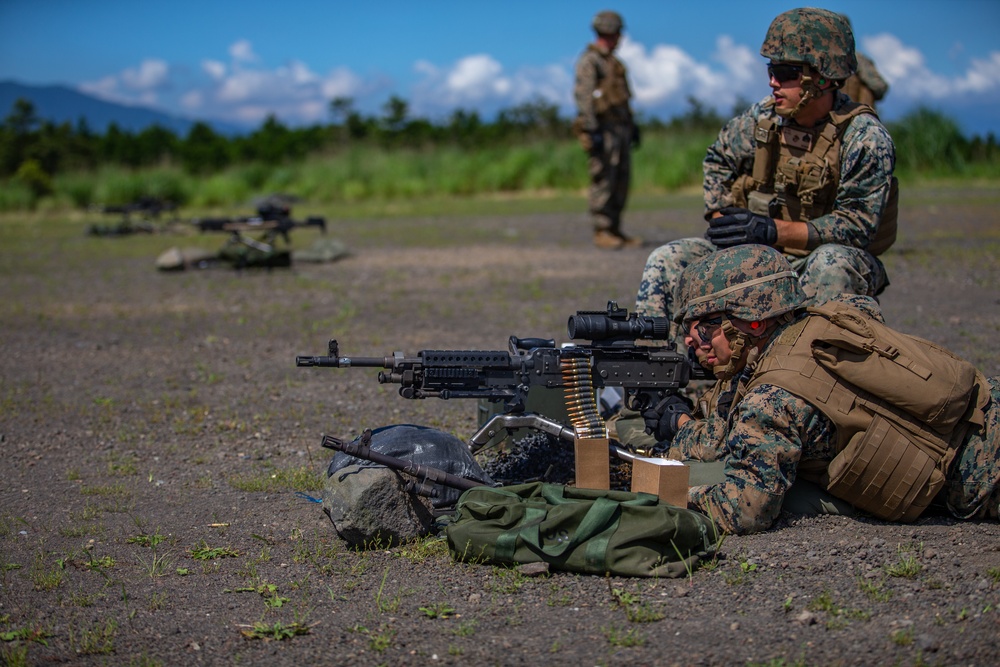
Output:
[760, 7, 858, 118]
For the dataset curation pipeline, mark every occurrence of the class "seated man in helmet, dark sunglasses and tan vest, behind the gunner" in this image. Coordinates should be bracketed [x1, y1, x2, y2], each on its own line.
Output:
[636, 8, 897, 334]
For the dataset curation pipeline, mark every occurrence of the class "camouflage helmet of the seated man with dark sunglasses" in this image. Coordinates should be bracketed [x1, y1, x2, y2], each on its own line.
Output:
[760, 7, 858, 81]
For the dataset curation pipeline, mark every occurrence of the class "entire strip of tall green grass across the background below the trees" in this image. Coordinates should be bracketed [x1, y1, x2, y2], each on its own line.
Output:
[0, 109, 1000, 211]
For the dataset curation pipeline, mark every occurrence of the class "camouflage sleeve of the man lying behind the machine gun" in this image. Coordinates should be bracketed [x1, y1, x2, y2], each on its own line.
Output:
[688, 385, 835, 534]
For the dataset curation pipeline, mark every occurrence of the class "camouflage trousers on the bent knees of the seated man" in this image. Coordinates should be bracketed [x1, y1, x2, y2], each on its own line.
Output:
[635, 238, 889, 338]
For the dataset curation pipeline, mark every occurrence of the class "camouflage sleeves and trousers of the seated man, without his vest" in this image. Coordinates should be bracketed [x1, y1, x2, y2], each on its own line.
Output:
[636, 93, 896, 328]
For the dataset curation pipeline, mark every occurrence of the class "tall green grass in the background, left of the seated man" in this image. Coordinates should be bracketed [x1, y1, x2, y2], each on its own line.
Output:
[21, 133, 713, 210]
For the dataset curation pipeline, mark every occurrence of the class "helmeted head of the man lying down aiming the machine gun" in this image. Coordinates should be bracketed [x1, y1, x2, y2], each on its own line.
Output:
[675, 244, 805, 379]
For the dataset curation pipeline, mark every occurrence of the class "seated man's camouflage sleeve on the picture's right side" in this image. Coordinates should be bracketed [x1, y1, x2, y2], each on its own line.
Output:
[810, 109, 896, 248]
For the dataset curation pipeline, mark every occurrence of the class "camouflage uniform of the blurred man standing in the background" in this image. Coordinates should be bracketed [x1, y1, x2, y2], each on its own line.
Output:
[573, 44, 634, 236]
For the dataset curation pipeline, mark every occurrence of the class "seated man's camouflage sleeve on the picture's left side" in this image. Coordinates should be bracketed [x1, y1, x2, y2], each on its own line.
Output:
[702, 98, 770, 219]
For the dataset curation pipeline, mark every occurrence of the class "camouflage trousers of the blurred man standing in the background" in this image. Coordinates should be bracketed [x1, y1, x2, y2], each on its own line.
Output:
[587, 125, 632, 233]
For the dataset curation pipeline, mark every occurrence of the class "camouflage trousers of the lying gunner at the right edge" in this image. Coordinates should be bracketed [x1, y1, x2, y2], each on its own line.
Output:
[938, 376, 1000, 519]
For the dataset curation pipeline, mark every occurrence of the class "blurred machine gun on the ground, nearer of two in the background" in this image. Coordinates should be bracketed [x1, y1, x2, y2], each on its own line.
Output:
[191, 195, 326, 269]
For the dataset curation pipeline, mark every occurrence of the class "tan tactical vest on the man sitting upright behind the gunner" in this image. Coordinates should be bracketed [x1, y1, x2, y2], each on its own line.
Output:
[732, 101, 899, 257]
